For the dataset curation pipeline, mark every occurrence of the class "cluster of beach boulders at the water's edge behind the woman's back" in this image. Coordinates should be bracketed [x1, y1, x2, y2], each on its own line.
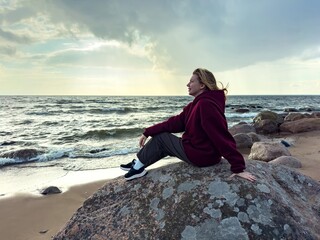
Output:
[229, 111, 320, 168]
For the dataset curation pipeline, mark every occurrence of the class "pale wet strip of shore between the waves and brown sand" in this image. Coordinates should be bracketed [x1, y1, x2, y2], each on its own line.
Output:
[0, 167, 123, 201]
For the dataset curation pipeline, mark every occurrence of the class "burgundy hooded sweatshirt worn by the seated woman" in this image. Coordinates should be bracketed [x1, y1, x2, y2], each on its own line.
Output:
[143, 90, 245, 173]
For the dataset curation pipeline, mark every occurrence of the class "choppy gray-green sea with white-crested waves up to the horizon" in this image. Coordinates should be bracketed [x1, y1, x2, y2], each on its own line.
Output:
[0, 95, 320, 171]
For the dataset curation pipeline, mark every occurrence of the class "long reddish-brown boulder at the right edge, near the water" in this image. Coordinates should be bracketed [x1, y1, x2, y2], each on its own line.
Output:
[280, 118, 320, 133]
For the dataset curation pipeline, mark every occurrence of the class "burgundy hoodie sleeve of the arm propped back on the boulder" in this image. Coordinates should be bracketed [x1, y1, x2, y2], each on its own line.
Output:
[200, 101, 245, 173]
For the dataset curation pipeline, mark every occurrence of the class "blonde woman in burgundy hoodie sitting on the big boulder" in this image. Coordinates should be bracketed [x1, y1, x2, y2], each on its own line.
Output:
[120, 68, 255, 181]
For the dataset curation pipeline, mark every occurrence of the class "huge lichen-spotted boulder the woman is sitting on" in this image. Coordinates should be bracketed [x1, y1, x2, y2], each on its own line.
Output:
[54, 160, 320, 240]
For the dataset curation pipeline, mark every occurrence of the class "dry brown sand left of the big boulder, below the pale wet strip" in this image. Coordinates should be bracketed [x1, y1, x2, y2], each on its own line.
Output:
[0, 181, 106, 240]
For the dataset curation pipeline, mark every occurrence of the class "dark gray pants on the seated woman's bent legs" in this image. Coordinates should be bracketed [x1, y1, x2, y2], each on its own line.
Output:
[137, 132, 192, 167]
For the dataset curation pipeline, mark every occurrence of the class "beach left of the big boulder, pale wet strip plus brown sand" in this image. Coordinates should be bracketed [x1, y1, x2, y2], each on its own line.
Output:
[0, 168, 123, 240]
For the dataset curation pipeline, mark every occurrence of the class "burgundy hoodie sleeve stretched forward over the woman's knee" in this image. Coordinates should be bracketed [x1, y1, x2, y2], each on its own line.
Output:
[143, 105, 189, 137]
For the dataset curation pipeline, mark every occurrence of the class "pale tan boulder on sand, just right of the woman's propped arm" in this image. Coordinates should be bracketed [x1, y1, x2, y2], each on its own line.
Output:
[248, 142, 291, 162]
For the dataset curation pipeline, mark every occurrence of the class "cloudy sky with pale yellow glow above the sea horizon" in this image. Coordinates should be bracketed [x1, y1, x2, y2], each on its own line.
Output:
[0, 0, 320, 95]
